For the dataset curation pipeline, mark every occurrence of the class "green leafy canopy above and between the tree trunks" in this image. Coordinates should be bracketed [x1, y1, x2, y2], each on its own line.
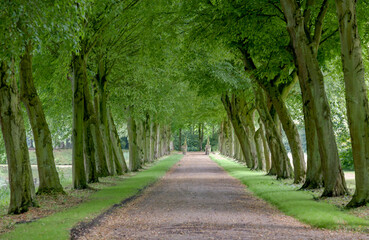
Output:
[0, 0, 369, 216]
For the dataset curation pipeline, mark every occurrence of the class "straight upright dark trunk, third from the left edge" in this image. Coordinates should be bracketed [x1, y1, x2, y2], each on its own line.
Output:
[72, 53, 87, 189]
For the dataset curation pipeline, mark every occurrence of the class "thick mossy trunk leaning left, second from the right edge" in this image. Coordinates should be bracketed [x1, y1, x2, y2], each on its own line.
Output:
[281, 0, 347, 197]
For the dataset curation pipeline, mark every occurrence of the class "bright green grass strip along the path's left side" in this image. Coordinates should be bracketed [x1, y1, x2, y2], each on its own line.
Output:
[0, 154, 183, 240]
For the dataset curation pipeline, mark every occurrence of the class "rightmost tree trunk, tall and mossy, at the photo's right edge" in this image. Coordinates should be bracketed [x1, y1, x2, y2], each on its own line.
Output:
[336, 0, 369, 207]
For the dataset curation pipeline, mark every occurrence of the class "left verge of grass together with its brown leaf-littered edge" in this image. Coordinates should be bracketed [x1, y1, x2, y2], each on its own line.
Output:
[0, 154, 183, 240]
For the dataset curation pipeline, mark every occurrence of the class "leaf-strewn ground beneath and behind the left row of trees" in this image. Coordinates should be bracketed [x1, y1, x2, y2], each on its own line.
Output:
[0, 149, 128, 235]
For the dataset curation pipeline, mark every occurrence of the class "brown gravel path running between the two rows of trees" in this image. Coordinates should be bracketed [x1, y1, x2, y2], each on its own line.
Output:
[80, 153, 369, 239]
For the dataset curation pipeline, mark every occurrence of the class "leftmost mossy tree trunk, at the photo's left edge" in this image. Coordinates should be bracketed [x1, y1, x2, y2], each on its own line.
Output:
[0, 62, 36, 214]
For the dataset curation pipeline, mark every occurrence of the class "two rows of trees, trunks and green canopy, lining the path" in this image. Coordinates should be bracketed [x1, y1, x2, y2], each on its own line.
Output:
[0, 0, 369, 214]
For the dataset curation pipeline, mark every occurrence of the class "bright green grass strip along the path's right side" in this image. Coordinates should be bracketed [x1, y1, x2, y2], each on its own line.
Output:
[211, 155, 369, 232]
